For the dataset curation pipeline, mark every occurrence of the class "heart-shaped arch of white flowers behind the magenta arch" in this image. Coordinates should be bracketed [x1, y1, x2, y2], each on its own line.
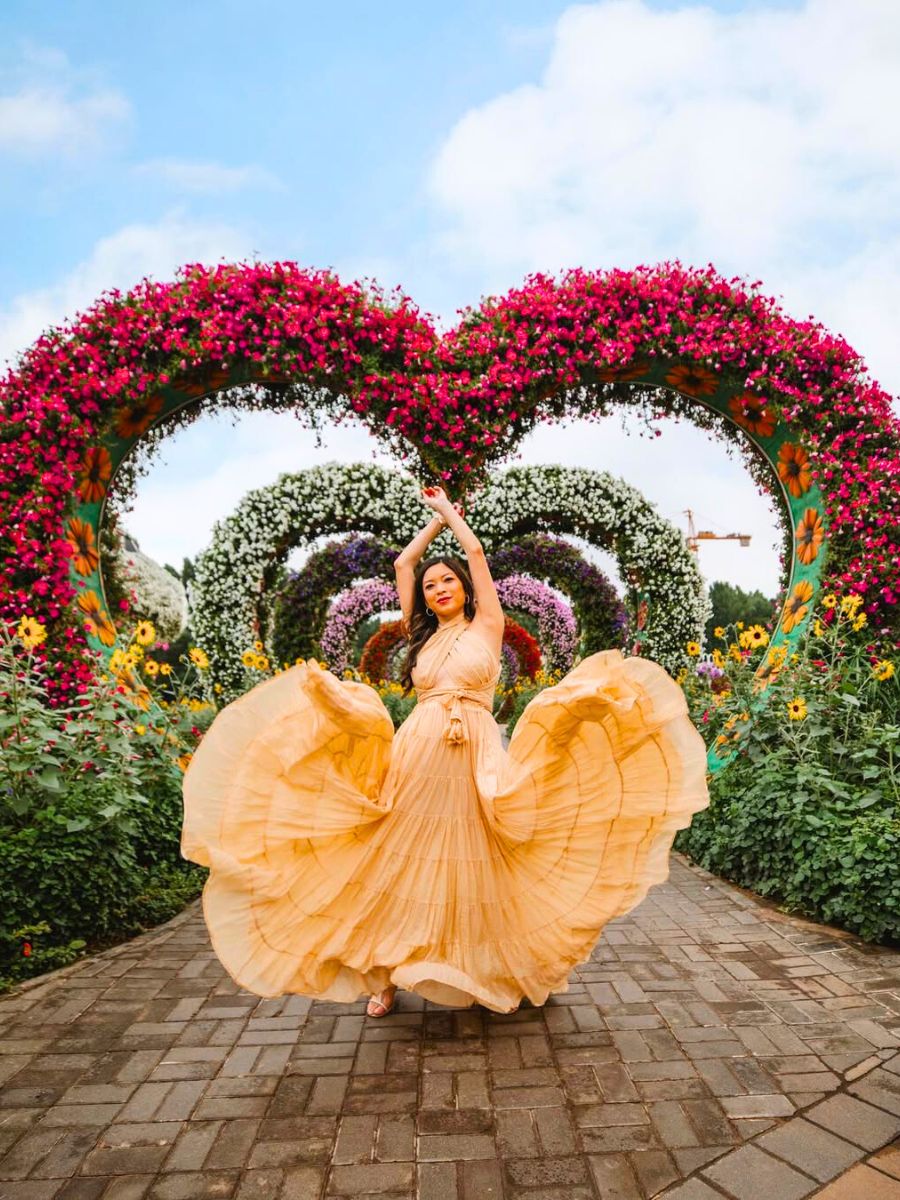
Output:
[188, 463, 709, 701]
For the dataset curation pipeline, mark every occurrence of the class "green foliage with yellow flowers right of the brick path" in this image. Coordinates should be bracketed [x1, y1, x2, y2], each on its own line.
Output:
[676, 605, 900, 942]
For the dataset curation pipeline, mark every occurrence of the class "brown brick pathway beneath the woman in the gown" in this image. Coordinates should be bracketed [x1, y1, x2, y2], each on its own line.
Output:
[0, 856, 900, 1200]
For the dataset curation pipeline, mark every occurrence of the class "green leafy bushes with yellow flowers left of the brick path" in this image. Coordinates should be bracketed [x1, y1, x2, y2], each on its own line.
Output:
[0, 630, 211, 985]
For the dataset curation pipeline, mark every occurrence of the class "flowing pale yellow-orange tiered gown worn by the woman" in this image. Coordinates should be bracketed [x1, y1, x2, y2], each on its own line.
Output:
[181, 613, 709, 1013]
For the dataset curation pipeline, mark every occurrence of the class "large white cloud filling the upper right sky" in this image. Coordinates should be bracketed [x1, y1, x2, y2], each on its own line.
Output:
[428, 0, 900, 390]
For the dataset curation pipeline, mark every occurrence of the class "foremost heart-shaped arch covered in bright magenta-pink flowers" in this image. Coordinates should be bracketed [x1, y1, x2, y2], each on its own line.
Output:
[0, 263, 900, 724]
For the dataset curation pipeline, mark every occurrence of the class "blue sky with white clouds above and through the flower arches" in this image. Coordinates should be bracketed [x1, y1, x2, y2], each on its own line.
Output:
[0, 0, 900, 595]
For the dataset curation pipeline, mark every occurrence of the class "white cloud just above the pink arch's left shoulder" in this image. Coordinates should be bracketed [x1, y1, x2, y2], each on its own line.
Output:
[0, 212, 252, 361]
